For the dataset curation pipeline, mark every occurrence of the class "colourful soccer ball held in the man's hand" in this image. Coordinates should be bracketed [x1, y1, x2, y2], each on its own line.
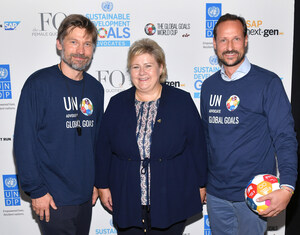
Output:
[245, 174, 280, 213]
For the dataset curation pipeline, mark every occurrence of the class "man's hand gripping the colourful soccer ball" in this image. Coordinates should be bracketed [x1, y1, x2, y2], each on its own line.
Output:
[257, 186, 292, 217]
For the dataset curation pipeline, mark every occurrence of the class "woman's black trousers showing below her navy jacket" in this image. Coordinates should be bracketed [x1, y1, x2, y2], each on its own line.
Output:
[118, 206, 186, 235]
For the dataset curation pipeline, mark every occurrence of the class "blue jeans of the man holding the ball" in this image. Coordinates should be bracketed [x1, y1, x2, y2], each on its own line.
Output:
[207, 194, 267, 235]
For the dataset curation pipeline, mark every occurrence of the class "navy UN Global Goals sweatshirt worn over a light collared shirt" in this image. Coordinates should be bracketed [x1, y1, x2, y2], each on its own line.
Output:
[201, 65, 297, 201]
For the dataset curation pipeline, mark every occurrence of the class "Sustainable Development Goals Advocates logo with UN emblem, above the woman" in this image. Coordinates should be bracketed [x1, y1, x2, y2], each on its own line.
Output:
[86, 1, 130, 47]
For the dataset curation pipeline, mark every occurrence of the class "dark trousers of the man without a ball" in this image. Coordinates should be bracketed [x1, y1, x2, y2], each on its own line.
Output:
[40, 201, 92, 235]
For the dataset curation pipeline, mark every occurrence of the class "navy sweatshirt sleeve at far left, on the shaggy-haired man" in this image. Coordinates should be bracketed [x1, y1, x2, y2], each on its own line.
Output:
[14, 80, 48, 198]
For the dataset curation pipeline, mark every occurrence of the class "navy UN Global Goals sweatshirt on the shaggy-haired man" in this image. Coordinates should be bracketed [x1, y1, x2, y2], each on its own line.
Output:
[14, 65, 104, 206]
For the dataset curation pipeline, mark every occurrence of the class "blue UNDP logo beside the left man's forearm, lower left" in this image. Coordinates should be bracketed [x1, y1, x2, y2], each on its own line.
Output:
[2, 175, 21, 206]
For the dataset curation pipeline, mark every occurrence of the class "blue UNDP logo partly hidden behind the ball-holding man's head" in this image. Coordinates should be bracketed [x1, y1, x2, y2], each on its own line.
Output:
[205, 3, 222, 38]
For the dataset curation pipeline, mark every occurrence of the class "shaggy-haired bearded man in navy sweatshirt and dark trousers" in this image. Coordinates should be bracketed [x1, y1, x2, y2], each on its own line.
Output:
[14, 15, 104, 235]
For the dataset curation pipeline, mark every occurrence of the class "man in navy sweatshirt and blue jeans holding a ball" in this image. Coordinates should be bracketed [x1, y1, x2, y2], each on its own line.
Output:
[201, 14, 297, 235]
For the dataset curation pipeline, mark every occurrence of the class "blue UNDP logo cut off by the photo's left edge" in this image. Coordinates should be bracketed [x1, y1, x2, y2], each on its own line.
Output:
[0, 64, 12, 99]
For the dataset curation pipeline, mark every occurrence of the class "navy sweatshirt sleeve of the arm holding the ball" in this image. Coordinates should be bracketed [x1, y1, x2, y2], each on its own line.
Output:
[263, 76, 298, 187]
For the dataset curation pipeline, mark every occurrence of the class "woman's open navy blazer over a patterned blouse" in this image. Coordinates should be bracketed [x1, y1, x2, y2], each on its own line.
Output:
[95, 84, 207, 228]
